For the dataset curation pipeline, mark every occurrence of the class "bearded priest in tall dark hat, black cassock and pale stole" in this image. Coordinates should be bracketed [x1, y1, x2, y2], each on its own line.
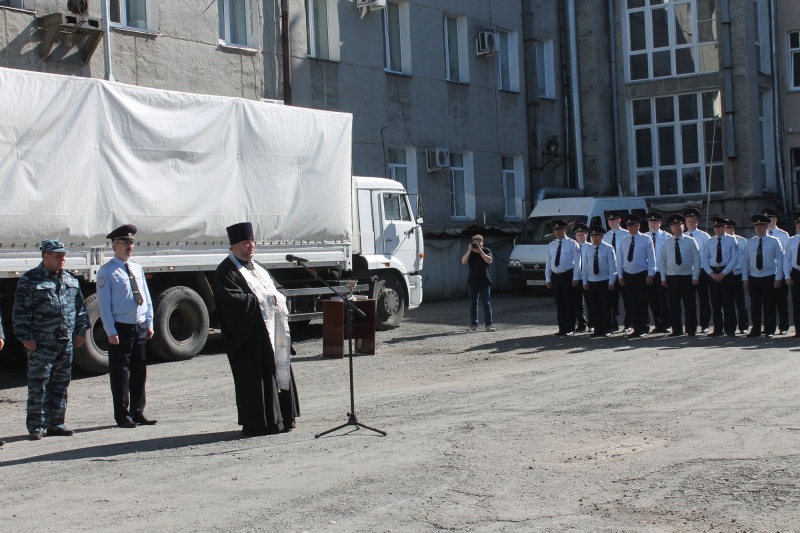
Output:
[213, 222, 300, 436]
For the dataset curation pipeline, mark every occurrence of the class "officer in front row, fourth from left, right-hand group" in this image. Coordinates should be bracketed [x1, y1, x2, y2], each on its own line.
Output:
[659, 214, 700, 337]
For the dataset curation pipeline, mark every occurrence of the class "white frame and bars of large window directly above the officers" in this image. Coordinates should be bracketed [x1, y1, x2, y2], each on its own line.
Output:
[627, 90, 725, 198]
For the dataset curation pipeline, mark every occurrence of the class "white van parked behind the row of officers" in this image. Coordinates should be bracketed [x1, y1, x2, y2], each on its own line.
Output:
[508, 196, 647, 290]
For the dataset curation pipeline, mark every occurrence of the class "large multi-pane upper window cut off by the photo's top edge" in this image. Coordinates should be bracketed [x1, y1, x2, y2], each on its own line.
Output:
[626, 0, 719, 81]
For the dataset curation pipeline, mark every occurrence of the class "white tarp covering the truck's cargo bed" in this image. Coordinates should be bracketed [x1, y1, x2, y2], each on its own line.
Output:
[0, 68, 353, 247]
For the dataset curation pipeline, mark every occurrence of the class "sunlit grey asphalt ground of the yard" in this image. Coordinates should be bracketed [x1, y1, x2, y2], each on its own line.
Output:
[0, 294, 800, 532]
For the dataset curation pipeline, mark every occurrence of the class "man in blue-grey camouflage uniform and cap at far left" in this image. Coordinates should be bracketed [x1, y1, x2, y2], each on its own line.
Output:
[13, 239, 89, 440]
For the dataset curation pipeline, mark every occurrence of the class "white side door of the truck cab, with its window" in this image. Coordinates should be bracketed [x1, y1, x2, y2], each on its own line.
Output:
[379, 192, 418, 272]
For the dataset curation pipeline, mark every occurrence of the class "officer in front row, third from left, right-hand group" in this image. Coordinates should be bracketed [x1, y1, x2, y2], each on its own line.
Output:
[617, 214, 656, 338]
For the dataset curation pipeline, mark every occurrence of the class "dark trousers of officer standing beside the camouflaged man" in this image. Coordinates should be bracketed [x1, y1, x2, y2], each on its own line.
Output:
[108, 322, 147, 424]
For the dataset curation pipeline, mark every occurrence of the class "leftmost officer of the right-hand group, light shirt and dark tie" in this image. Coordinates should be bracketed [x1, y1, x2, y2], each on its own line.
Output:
[544, 220, 581, 337]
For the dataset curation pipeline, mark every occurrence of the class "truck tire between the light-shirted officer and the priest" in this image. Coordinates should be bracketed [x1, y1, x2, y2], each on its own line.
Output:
[151, 287, 208, 361]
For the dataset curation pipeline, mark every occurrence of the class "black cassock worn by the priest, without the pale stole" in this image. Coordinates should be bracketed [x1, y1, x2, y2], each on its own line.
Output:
[213, 257, 300, 433]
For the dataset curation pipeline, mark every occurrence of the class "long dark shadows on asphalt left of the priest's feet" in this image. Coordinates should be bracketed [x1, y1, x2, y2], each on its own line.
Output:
[0, 426, 250, 468]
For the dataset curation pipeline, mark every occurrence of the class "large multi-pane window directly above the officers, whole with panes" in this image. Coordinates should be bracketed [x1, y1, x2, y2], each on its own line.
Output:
[630, 91, 725, 196]
